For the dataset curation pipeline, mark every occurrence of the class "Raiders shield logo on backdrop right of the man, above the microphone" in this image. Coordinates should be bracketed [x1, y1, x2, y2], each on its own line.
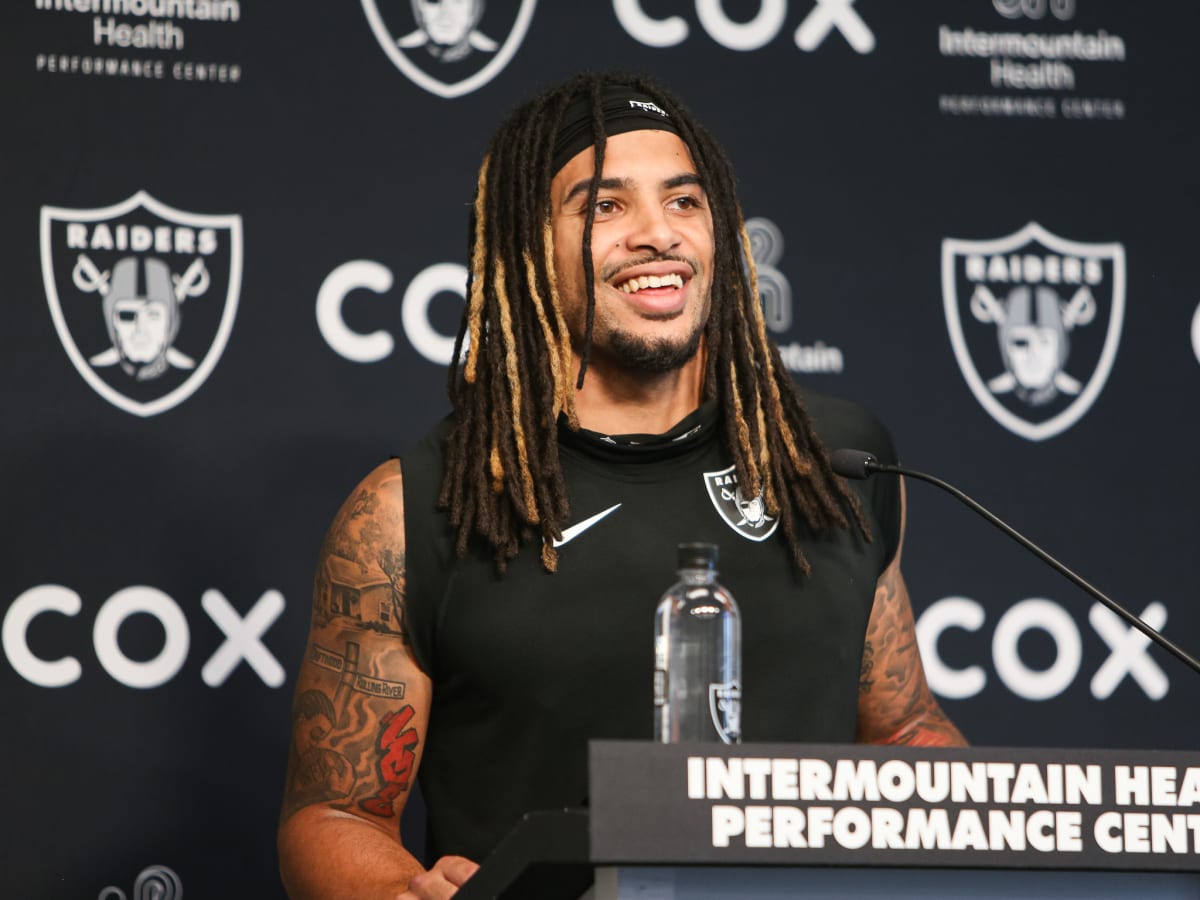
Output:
[942, 222, 1126, 440]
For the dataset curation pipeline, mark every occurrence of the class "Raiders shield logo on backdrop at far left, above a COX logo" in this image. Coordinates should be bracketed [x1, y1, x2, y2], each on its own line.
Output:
[41, 191, 241, 416]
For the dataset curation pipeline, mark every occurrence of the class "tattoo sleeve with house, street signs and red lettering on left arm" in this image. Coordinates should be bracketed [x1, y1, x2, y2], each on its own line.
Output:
[283, 476, 425, 820]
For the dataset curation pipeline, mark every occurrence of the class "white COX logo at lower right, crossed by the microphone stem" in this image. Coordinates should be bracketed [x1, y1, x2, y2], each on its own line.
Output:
[917, 596, 1170, 700]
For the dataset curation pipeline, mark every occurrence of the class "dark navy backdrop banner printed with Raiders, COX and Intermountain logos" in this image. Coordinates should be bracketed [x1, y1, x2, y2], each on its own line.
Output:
[0, 0, 1200, 900]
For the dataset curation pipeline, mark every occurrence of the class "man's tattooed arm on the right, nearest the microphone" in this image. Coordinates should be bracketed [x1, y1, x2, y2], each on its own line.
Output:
[858, 482, 967, 746]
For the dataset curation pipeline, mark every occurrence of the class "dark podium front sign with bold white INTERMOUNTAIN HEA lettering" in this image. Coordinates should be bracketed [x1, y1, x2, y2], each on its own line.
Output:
[589, 742, 1200, 871]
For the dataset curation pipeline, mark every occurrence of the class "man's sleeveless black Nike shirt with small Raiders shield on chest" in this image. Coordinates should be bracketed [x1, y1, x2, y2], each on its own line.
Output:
[402, 394, 900, 860]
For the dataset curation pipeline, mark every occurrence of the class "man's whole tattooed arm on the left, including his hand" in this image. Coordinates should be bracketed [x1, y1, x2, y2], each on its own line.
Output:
[278, 460, 475, 900]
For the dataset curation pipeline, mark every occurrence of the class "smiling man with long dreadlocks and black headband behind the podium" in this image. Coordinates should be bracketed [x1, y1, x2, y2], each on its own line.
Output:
[280, 76, 962, 898]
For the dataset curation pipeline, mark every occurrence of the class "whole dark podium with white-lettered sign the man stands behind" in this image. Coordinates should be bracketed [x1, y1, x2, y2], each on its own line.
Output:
[458, 742, 1200, 900]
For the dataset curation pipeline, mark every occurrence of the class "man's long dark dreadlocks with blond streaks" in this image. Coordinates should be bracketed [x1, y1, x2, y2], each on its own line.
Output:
[438, 74, 871, 575]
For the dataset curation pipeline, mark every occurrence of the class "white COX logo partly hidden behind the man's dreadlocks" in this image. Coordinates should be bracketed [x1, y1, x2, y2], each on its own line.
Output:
[317, 259, 467, 366]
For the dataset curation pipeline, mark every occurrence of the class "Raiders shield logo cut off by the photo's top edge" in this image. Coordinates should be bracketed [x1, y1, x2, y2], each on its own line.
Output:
[362, 0, 538, 100]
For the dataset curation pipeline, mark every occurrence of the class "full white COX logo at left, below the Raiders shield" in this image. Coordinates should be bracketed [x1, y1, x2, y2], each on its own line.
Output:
[2, 584, 284, 688]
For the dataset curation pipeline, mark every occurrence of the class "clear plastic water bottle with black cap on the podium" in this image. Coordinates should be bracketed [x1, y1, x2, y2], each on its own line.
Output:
[654, 544, 742, 744]
